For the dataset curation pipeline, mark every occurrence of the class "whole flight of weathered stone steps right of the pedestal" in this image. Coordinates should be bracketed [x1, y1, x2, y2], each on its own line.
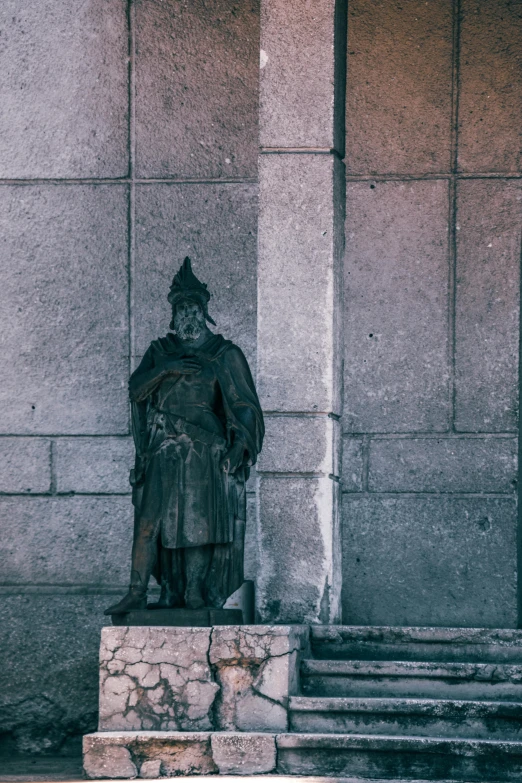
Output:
[277, 626, 522, 783]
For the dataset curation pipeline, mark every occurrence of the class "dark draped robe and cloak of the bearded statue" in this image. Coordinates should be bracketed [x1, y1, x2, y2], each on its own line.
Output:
[131, 334, 264, 606]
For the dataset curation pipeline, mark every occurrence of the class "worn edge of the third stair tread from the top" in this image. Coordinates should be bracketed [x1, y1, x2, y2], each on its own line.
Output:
[289, 696, 522, 718]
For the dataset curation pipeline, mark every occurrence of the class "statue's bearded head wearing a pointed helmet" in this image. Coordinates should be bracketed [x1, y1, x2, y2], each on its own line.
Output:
[168, 256, 215, 340]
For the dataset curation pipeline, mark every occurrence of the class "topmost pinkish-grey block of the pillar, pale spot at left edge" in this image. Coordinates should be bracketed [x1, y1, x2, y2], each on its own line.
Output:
[259, 0, 344, 153]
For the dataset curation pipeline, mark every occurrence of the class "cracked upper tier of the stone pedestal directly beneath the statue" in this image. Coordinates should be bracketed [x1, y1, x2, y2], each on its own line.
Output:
[98, 624, 309, 732]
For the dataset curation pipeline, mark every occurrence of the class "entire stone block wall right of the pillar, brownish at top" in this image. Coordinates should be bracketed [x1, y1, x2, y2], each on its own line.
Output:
[343, 0, 522, 627]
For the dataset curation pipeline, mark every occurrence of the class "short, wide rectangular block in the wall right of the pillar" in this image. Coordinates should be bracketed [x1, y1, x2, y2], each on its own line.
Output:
[368, 438, 517, 493]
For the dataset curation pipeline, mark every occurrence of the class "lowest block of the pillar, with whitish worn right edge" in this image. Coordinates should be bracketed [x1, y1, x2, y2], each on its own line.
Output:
[256, 477, 340, 623]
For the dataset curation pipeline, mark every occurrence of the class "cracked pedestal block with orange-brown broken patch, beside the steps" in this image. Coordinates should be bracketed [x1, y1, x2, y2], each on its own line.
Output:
[209, 625, 308, 731]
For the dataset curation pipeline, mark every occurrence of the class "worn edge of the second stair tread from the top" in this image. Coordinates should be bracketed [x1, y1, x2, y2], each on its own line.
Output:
[301, 659, 522, 683]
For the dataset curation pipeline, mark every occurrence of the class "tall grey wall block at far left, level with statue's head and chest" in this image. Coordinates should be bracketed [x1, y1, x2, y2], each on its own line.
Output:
[0, 185, 129, 434]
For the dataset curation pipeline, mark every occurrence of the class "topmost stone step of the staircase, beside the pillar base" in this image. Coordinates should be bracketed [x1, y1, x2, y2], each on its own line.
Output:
[310, 625, 522, 664]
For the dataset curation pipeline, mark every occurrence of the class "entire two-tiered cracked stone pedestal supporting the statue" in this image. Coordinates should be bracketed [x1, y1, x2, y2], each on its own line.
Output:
[84, 625, 309, 778]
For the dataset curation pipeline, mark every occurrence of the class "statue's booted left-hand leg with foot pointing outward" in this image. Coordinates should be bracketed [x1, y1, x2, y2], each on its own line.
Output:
[105, 518, 158, 614]
